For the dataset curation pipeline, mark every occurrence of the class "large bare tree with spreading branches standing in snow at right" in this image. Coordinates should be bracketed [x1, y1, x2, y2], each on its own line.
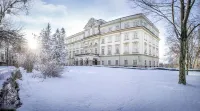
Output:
[131, 0, 200, 85]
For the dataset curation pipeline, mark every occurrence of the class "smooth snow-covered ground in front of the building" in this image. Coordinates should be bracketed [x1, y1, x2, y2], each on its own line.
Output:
[18, 66, 200, 111]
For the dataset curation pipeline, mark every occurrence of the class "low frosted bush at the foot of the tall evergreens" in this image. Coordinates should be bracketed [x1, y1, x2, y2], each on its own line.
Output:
[40, 61, 63, 78]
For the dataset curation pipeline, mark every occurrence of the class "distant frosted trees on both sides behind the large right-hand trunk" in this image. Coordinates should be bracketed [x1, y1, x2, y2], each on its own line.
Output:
[167, 28, 200, 70]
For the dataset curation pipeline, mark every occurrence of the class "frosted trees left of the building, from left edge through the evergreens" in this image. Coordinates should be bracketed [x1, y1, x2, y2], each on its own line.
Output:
[0, 0, 65, 77]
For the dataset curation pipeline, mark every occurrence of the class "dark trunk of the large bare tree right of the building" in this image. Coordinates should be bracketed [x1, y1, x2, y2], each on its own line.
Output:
[178, 33, 187, 85]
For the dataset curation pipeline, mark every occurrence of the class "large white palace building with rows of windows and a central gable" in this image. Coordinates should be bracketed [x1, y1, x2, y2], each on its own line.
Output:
[66, 14, 160, 67]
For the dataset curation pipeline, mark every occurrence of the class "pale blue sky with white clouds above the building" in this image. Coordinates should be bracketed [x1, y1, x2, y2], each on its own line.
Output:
[14, 0, 166, 62]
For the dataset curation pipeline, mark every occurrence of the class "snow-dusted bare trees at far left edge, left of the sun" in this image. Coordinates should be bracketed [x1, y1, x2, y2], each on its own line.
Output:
[0, 0, 31, 65]
